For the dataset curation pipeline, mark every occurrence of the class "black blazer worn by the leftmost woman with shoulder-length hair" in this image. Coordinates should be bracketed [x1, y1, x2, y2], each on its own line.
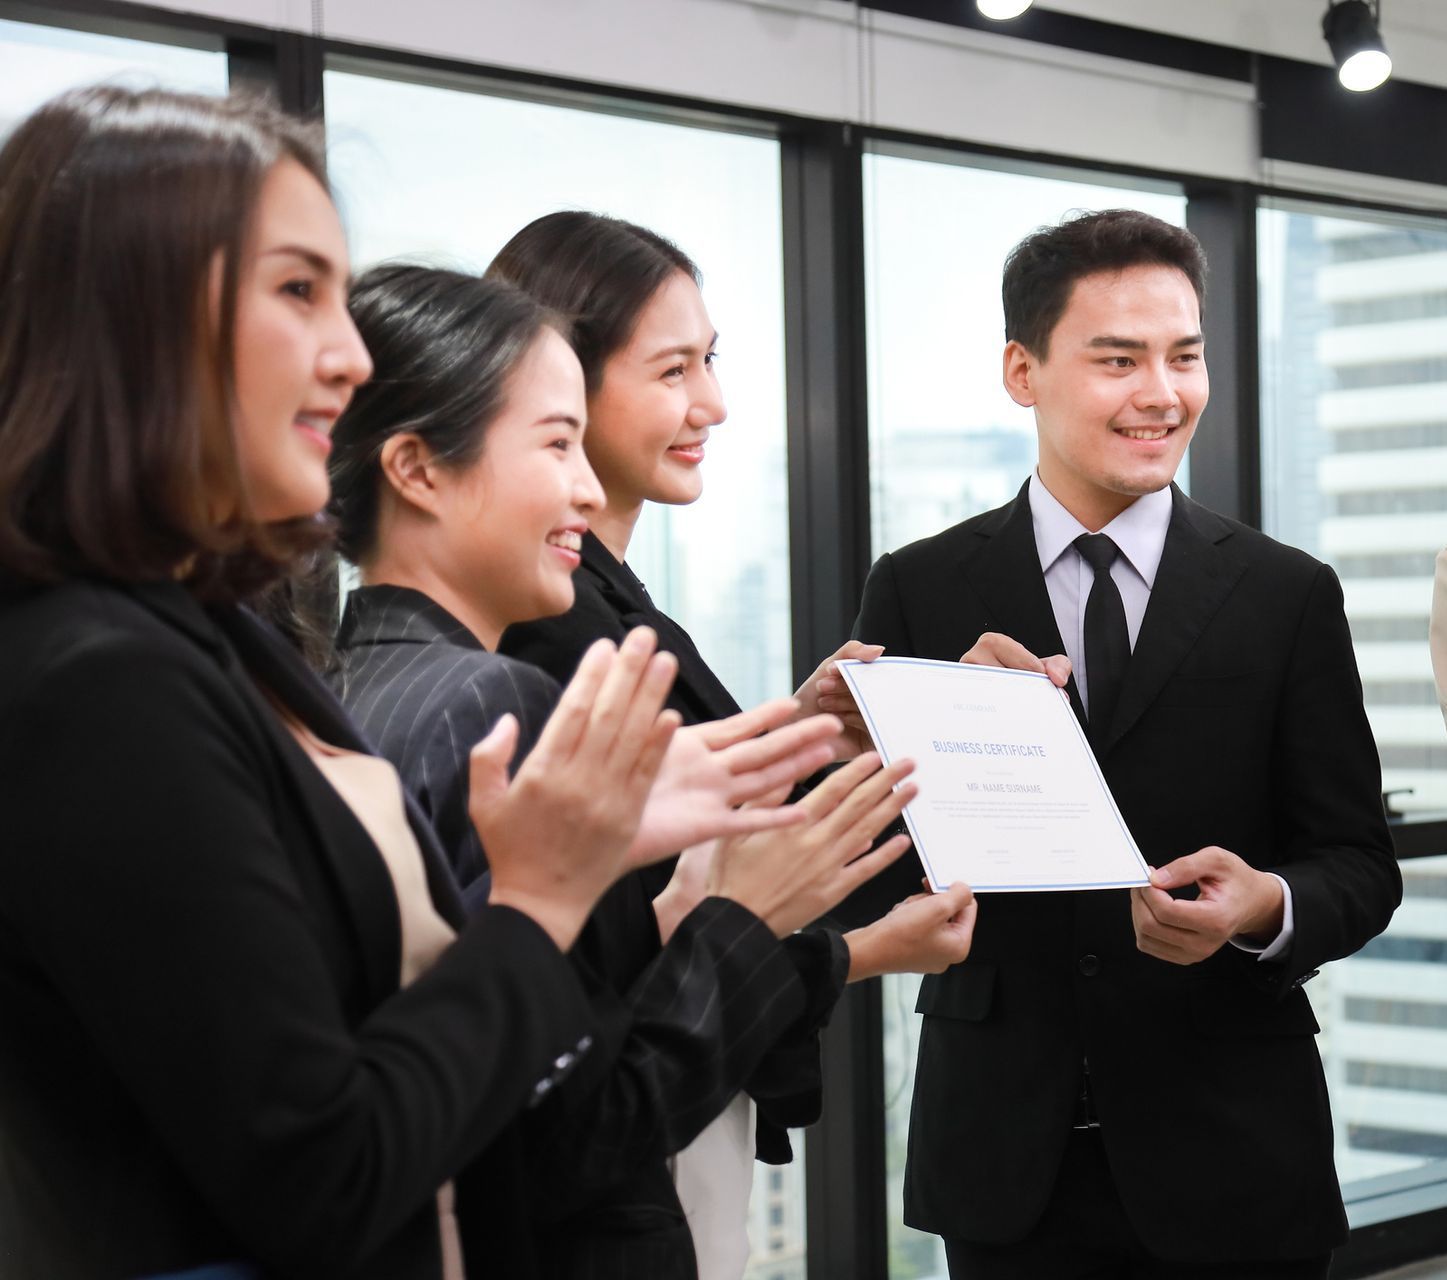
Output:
[0, 581, 595, 1280]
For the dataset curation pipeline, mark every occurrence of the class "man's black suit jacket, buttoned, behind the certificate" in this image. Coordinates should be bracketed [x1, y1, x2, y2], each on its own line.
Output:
[855, 489, 1401, 1261]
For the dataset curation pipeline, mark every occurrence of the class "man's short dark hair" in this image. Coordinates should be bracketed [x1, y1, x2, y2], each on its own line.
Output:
[1001, 208, 1205, 360]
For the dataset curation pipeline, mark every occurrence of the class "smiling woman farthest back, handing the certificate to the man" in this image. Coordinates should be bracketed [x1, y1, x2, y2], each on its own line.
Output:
[488, 211, 974, 1280]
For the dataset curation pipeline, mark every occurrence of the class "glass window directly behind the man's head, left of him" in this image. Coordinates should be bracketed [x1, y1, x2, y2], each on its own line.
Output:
[864, 152, 1192, 1280]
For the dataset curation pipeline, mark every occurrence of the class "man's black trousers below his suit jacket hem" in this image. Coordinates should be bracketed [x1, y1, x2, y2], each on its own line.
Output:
[945, 1130, 1331, 1280]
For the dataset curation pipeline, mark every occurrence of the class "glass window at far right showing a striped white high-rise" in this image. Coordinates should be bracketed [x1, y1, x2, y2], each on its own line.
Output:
[1257, 205, 1447, 1182]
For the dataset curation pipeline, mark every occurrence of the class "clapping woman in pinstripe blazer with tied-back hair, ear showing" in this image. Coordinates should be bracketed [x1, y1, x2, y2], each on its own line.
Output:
[331, 266, 968, 1280]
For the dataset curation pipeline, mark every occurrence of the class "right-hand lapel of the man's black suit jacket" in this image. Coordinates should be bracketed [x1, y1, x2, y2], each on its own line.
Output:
[1103, 485, 1246, 754]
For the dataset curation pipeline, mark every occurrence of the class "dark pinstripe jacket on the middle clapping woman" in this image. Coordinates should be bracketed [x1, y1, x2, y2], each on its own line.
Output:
[334, 586, 848, 1280]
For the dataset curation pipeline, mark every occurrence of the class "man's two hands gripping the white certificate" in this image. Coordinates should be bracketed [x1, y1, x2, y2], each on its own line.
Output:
[873, 632, 1283, 965]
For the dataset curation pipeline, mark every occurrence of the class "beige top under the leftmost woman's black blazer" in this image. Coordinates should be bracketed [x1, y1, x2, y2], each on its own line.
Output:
[278, 707, 466, 1280]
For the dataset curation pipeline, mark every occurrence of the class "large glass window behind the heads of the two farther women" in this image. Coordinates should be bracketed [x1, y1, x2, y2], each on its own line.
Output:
[326, 67, 805, 1280]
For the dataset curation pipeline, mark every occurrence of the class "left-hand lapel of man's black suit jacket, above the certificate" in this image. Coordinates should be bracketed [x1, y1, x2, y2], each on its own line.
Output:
[949, 482, 1085, 723]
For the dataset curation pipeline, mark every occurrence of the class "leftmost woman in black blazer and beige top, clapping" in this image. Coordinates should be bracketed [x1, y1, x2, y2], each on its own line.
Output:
[0, 88, 746, 1280]
